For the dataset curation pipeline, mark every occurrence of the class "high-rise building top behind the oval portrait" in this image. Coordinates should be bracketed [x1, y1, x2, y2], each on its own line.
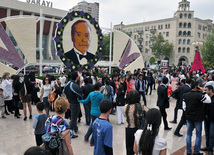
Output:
[69, 0, 99, 23]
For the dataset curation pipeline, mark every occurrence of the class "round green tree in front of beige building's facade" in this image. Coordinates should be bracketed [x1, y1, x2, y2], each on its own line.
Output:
[152, 35, 174, 59]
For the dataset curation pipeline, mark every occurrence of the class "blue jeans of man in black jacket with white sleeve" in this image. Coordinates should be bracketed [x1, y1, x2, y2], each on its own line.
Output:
[186, 120, 202, 154]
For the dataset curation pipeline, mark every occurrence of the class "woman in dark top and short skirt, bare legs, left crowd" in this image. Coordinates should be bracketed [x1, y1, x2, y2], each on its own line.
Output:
[21, 75, 33, 121]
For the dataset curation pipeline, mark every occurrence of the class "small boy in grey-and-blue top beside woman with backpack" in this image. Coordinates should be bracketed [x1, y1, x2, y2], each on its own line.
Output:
[32, 102, 47, 146]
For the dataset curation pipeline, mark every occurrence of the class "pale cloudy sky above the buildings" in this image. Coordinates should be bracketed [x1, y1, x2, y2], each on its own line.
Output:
[20, 0, 214, 28]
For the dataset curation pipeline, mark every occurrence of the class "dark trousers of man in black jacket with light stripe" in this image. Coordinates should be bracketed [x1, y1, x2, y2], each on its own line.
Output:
[70, 103, 80, 132]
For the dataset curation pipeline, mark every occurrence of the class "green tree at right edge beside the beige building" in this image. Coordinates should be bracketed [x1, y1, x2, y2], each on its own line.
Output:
[201, 29, 214, 68]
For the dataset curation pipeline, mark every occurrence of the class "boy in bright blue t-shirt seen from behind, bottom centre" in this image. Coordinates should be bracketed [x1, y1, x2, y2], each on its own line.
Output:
[92, 99, 113, 155]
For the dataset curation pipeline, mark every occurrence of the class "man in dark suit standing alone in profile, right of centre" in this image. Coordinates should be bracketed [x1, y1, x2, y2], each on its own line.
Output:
[157, 77, 172, 130]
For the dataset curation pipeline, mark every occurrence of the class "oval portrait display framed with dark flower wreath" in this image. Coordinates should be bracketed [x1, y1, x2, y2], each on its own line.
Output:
[54, 11, 103, 71]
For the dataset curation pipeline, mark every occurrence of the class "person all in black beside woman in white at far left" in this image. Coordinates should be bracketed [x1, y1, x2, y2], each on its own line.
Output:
[12, 75, 22, 118]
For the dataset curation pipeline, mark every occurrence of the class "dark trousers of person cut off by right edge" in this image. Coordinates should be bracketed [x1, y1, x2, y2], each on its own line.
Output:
[204, 116, 214, 152]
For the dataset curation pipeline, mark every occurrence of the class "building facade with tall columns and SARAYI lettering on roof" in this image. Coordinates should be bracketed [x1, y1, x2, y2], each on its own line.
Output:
[0, 0, 68, 63]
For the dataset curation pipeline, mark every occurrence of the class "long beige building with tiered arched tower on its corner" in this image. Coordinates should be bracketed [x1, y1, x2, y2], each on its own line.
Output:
[114, 0, 213, 65]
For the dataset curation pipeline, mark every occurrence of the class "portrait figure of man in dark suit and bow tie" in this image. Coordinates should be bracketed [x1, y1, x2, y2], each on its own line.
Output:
[65, 20, 94, 65]
